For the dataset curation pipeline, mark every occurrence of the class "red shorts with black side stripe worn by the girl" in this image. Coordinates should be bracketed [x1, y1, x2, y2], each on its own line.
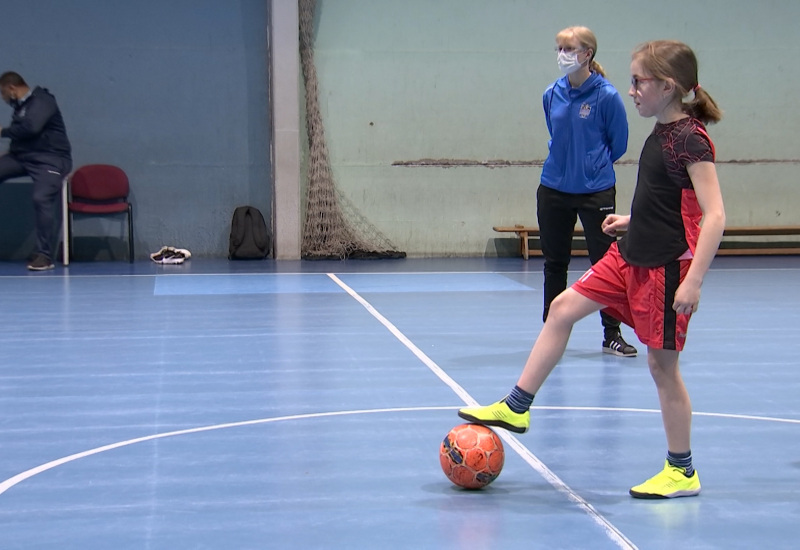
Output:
[572, 243, 692, 351]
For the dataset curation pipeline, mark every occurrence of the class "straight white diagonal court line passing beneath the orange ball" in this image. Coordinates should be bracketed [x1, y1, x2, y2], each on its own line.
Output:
[328, 273, 637, 550]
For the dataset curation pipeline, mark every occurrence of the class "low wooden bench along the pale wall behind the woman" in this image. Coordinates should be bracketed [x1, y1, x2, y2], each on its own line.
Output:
[492, 225, 800, 260]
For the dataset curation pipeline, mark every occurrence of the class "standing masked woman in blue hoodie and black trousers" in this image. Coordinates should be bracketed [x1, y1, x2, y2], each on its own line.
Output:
[536, 27, 637, 357]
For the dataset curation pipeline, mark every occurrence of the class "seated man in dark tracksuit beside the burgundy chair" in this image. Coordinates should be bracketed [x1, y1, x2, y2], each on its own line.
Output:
[0, 72, 72, 271]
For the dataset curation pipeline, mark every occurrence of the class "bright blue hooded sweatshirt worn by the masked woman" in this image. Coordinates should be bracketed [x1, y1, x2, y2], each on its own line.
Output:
[541, 73, 628, 194]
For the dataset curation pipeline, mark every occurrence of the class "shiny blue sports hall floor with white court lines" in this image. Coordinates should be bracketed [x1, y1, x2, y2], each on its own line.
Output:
[0, 257, 800, 550]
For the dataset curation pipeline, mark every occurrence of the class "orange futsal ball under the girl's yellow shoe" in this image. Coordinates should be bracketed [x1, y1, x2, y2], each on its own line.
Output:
[439, 424, 506, 489]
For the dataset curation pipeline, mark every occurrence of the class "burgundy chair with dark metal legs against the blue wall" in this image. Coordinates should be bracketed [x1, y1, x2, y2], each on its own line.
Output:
[64, 164, 134, 263]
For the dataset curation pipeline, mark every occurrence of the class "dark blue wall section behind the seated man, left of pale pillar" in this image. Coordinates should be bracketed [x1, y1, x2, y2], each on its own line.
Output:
[0, 0, 272, 259]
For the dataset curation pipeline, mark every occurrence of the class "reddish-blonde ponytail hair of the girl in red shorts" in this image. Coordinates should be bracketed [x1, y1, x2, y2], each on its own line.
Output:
[631, 40, 722, 124]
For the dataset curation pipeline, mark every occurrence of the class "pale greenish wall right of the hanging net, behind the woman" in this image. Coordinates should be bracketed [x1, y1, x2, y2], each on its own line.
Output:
[296, 0, 800, 256]
